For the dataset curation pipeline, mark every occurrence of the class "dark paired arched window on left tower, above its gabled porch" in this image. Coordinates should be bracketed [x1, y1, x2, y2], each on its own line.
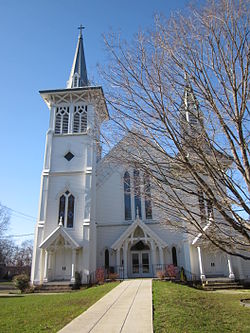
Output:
[58, 191, 75, 228]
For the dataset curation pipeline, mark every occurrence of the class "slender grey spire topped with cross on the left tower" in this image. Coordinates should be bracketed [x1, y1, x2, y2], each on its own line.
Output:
[67, 25, 88, 88]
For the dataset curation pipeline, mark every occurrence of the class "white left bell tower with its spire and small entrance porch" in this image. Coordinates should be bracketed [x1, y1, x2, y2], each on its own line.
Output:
[31, 25, 109, 284]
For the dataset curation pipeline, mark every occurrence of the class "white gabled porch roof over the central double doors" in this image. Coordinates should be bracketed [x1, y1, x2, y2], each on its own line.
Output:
[111, 215, 168, 250]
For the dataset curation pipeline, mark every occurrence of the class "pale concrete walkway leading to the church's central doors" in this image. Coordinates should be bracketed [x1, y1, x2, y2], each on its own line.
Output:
[59, 279, 153, 333]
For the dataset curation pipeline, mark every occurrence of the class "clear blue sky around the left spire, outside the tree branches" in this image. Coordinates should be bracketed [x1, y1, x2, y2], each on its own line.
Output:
[0, 0, 187, 242]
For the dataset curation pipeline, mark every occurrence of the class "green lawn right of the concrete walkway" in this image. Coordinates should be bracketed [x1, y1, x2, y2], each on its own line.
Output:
[153, 281, 250, 333]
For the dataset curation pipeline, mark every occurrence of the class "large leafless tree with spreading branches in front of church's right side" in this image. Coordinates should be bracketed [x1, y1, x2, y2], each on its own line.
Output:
[100, 0, 250, 259]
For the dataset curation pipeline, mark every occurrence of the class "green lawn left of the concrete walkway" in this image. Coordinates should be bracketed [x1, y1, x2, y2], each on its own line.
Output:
[0, 283, 118, 333]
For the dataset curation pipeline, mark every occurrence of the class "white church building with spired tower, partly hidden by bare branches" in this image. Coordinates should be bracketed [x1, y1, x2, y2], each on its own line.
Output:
[31, 29, 250, 285]
